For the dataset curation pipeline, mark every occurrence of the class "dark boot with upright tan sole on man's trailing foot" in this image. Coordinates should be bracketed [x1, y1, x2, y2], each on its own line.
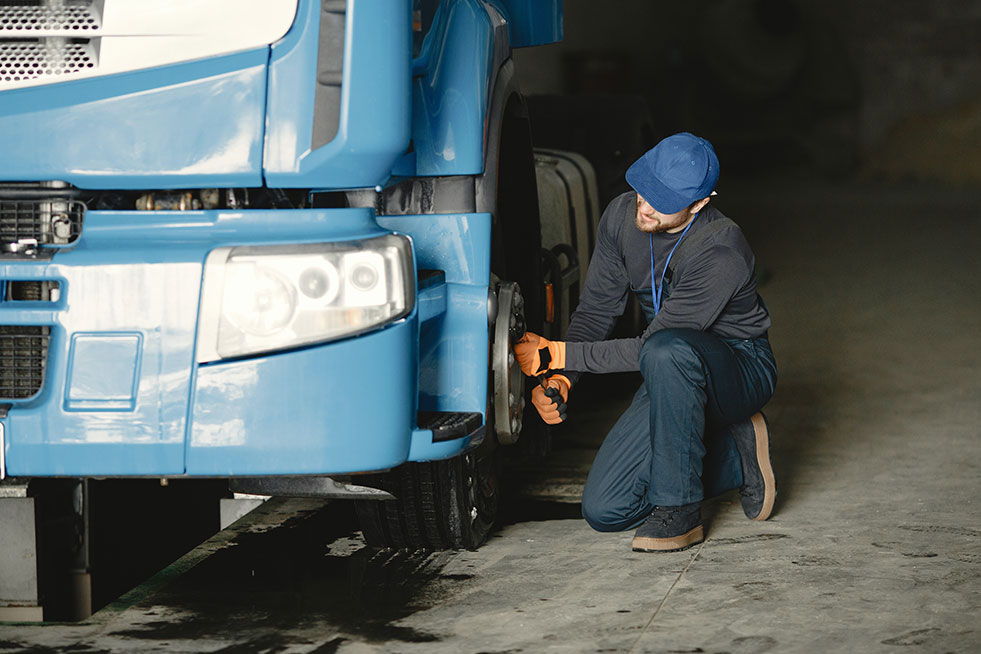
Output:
[728, 413, 777, 520]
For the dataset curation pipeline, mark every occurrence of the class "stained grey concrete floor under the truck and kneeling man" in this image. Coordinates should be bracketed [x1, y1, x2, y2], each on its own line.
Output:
[0, 184, 981, 654]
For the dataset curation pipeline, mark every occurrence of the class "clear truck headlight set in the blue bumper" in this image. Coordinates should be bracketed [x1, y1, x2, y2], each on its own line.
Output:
[197, 234, 415, 363]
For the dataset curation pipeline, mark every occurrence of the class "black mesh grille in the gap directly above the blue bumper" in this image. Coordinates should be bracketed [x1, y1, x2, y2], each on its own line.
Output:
[0, 199, 85, 251]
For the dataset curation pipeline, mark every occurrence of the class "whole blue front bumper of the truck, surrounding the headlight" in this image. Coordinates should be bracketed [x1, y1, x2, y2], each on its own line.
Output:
[0, 209, 418, 476]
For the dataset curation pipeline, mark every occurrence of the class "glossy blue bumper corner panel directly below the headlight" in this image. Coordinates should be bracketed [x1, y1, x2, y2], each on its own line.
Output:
[187, 319, 417, 476]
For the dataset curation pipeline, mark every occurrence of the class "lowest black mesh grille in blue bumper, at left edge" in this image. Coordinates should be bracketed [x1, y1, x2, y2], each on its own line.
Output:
[0, 325, 51, 400]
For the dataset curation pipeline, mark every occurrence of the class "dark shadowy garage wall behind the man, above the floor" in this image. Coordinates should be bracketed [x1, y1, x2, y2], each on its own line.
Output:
[516, 0, 981, 184]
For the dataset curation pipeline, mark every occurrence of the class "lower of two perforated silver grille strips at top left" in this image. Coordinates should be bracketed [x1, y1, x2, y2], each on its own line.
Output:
[0, 39, 96, 82]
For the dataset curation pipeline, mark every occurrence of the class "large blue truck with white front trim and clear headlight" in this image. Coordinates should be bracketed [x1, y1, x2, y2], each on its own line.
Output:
[0, 0, 562, 560]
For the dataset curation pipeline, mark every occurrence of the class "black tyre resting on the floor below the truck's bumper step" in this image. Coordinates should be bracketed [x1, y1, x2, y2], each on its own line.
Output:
[355, 447, 498, 550]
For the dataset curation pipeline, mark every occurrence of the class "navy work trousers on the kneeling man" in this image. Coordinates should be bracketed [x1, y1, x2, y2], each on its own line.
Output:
[582, 329, 777, 531]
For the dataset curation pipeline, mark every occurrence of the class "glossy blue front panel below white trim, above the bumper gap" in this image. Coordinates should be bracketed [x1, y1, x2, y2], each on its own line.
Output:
[0, 47, 269, 189]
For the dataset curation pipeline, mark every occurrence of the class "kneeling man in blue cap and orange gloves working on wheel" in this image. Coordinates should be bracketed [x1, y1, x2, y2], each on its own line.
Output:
[515, 132, 776, 552]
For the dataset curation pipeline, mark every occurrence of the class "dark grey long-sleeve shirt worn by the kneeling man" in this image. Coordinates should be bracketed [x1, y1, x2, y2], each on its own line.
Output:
[565, 191, 770, 376]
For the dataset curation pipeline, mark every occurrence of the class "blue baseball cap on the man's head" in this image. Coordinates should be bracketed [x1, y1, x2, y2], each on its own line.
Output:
[627, 132, 719, 213]
